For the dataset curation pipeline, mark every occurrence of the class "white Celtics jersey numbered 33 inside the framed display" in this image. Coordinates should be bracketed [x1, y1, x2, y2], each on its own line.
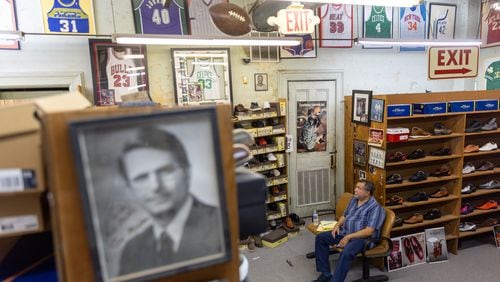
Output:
[189, 58, 224, 100]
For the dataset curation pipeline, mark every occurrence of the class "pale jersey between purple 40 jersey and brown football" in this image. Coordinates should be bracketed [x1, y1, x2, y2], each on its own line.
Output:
[188, 0, 227, 37]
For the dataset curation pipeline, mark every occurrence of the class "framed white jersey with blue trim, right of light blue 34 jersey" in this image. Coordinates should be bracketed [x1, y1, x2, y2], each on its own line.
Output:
[427, 3, 457, 40]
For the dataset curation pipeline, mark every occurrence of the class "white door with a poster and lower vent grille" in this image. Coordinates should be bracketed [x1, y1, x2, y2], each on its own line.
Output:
[288, 80, 336, 216]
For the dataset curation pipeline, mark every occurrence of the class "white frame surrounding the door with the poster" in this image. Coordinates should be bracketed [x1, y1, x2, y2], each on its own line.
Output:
[278, 69, 345, 203]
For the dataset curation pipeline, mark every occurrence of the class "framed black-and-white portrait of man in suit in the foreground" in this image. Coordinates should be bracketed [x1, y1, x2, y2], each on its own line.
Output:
[70, 107, 231, 281]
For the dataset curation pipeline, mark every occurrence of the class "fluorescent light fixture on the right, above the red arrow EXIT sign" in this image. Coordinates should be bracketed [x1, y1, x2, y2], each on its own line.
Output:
[358, 38, 481, 47]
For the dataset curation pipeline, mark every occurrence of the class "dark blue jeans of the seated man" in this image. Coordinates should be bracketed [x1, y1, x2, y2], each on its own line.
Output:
[314, 231, 365, 282]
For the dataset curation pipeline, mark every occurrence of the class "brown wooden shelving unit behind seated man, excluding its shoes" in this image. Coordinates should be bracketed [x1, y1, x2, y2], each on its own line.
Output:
[344, 90, 500, 254]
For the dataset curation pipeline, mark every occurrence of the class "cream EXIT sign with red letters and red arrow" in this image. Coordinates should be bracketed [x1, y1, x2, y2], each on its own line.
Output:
[429, 47, 479, 79]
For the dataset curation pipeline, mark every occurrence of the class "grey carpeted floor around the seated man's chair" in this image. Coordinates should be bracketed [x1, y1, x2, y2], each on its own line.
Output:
[240, 220, 500, 282]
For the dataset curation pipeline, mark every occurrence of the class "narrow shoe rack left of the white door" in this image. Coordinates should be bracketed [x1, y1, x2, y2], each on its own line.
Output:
[233, 100, 288, 228]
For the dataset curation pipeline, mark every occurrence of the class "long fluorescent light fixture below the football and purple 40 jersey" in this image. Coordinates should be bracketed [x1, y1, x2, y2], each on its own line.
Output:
[112, 34, 302, 46]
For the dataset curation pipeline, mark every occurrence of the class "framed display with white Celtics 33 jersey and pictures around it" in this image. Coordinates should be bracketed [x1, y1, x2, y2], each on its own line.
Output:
[172, 49, 232, 105]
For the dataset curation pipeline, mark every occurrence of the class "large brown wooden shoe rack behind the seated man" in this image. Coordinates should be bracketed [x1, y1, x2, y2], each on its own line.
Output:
[345, 91, 500, 254]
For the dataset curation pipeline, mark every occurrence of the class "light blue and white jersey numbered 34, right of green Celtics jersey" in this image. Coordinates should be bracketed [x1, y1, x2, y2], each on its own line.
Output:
[399, 4, 426, 51]
